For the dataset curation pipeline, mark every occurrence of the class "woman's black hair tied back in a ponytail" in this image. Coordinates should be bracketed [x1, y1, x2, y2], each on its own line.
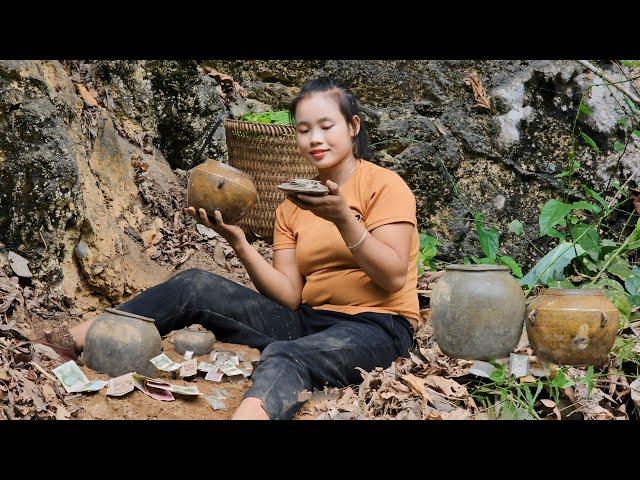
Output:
[289, 77, 371, 160]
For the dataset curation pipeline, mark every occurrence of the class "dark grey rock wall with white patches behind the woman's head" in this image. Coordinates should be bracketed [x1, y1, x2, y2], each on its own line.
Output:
[208, 60, 640, 266]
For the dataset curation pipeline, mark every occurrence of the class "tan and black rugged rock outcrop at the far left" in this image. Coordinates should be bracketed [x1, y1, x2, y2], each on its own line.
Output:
[0, 62, 215, 304]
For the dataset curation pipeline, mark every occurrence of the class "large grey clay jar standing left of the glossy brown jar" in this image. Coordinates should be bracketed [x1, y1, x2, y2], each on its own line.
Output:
[430, 265, 525, 360]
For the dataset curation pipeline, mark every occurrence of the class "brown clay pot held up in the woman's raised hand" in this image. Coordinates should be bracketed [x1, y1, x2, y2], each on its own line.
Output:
[187, 160, 258, 224]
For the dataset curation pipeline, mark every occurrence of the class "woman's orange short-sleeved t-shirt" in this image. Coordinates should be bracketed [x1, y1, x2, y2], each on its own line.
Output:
[273, 160, 420, 329]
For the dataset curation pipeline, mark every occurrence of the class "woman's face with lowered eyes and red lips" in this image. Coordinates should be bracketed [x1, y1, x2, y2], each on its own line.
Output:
[296, 93, 360, 169]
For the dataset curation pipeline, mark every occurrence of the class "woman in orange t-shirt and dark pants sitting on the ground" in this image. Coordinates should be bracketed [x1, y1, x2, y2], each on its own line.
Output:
[37, 78, 420, 419]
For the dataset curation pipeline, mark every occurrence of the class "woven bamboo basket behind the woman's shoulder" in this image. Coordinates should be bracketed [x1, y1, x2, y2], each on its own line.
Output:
[224, 118, 318, 242]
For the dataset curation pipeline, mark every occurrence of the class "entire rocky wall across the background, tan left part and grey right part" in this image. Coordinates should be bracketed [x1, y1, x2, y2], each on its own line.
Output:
[0, 60, 640, 310]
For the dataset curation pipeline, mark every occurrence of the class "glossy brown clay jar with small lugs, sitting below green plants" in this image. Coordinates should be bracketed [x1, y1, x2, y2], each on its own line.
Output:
[525, 288, 619, 365]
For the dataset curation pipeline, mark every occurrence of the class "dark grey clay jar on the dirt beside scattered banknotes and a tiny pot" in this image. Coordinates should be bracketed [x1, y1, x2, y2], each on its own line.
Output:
[82, 308, 162, 377]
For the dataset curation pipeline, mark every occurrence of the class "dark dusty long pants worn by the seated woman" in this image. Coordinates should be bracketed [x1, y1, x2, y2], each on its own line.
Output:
[118, 269, 413, 419]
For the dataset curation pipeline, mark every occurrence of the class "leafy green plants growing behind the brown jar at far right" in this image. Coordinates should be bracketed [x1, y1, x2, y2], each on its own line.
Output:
[520, 72, 640, 324]
